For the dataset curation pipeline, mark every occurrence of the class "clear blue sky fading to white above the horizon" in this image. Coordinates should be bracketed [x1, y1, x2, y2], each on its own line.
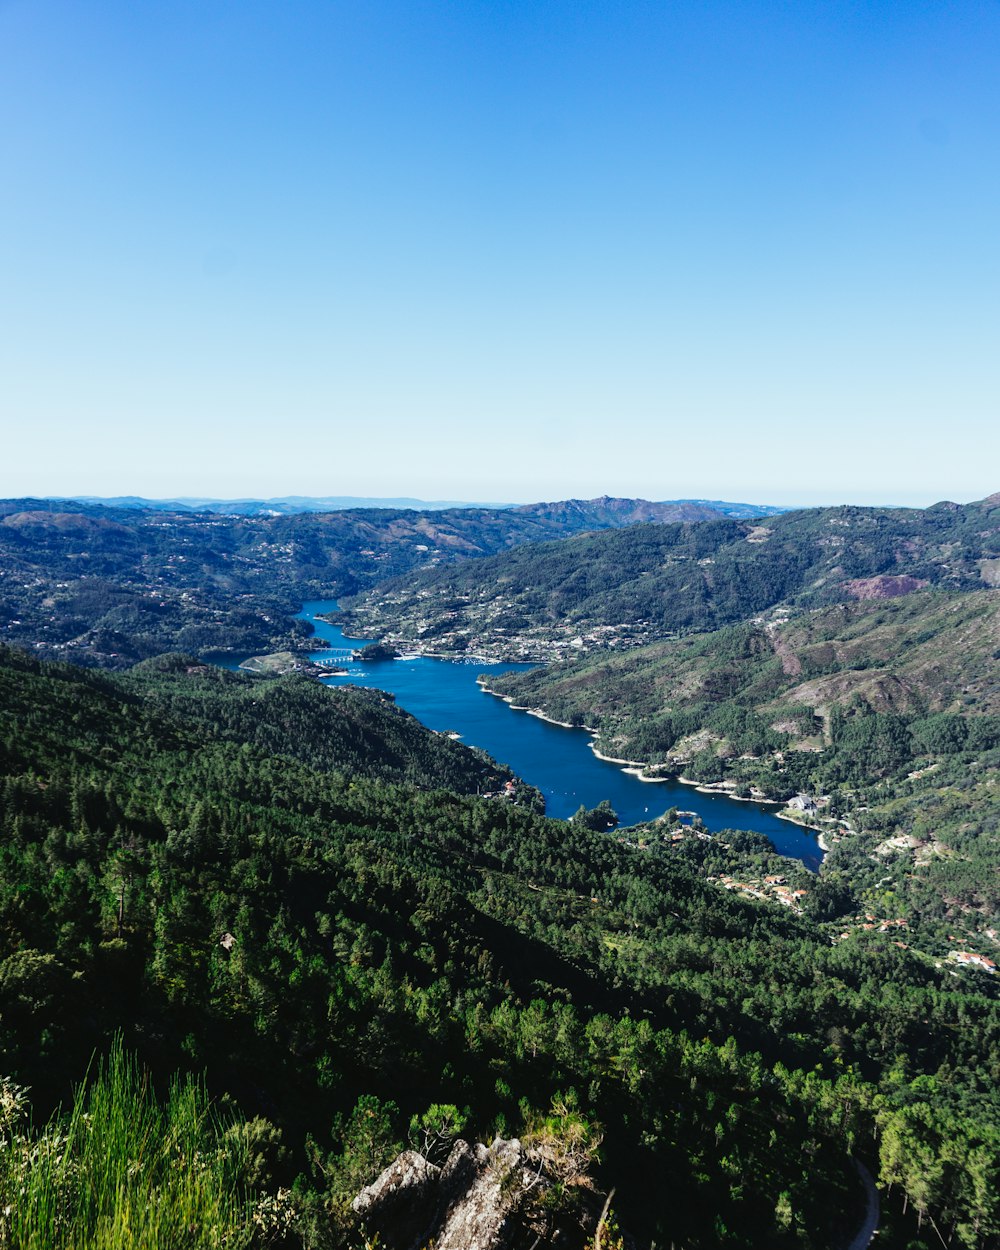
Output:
[0, 0, 1000, 503]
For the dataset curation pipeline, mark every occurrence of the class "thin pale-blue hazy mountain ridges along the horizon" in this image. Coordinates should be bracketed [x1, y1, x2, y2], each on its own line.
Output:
[46, 495, 791, 525]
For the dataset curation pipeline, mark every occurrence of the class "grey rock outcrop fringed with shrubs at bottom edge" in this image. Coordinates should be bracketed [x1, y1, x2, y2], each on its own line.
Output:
[351, 1139, 596, 1250]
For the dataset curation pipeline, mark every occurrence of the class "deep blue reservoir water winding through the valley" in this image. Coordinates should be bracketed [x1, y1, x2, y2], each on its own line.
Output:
[299, 600, 823, 869]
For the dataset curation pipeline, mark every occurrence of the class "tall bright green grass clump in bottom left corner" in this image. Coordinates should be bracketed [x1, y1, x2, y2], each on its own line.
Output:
[0, 1045, 263, 1250]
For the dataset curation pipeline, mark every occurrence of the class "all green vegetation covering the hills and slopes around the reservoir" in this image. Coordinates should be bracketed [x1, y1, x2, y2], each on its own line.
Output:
[0, 499, 1000, 1250]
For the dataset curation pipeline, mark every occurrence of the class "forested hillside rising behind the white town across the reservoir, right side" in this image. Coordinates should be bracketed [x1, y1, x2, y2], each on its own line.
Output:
[344, 496, 1000, 659]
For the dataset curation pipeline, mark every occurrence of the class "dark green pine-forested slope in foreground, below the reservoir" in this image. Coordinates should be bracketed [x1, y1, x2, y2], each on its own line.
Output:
[0, 650, 1000, 1250]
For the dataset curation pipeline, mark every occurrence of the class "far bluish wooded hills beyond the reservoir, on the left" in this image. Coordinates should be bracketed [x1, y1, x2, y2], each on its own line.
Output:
[0, 499, 755, 668]
